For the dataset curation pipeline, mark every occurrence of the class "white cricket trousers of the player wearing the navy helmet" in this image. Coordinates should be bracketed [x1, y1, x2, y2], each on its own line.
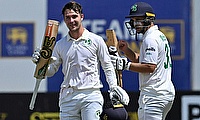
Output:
[138, 95, 174, 120]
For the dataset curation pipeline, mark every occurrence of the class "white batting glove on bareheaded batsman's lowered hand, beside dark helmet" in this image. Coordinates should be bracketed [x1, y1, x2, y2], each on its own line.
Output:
[109, 86, 130, 105]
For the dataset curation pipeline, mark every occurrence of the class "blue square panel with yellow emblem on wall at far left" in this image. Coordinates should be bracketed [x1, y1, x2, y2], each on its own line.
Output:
[0, 23, 34, 57]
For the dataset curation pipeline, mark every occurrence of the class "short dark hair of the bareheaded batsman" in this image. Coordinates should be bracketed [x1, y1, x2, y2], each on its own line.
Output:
[62, 1, 83, 15]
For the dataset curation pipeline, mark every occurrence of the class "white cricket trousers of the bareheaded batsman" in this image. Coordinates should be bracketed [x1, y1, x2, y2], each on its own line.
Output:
[59, 88, 103, 120]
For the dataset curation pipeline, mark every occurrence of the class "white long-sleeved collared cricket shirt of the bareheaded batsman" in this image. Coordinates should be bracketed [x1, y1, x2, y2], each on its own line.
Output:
[47, 29, 117, 89]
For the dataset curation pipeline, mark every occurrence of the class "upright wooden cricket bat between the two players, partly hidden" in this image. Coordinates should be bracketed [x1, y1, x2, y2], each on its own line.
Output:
[106, 29, 123, 87]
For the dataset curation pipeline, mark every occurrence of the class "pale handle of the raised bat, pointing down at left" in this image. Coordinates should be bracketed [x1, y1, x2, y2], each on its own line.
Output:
[29, 79, 42, 110]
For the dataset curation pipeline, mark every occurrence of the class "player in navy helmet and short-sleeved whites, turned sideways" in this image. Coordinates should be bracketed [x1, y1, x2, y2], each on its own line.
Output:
[111, 2, 175, 120]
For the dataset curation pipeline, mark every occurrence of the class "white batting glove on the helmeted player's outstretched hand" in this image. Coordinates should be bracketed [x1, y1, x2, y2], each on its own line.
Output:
[110, 55, 131, 70]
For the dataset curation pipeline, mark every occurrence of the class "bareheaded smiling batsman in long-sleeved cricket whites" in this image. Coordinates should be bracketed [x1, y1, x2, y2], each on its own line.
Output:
[30, 1, 129, 120]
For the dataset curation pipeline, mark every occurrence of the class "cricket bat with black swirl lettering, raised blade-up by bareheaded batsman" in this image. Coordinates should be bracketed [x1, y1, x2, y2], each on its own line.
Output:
[29, 20, 59, 110]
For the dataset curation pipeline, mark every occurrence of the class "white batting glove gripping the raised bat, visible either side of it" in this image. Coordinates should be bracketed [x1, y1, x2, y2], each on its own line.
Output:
[31, 48, 57, 64]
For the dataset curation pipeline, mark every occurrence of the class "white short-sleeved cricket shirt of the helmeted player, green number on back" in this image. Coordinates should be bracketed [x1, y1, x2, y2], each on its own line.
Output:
[139, 25, 175, 96]
